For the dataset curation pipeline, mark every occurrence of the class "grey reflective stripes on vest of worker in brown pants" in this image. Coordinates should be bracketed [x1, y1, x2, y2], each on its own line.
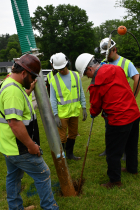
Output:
[54, 72, 80, 105]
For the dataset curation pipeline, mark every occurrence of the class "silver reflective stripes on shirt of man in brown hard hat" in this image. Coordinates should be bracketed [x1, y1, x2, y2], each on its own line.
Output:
[0, 82, 36, 125]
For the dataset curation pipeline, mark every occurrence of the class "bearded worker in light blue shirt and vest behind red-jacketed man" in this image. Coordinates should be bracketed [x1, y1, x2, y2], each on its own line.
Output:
[99, 38, 139, 157]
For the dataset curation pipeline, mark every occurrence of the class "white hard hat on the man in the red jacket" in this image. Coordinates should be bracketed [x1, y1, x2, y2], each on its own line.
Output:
[75, 53, 94, 77]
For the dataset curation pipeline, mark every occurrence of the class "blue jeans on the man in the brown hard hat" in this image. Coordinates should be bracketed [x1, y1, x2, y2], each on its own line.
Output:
[4, 153, 59, 210]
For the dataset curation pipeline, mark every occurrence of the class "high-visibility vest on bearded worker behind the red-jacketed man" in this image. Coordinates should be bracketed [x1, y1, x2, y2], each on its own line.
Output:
[103, 57, 130, 82]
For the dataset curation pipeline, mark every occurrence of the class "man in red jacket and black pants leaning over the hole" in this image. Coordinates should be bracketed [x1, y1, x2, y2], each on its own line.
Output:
[75, 53, 140, 188]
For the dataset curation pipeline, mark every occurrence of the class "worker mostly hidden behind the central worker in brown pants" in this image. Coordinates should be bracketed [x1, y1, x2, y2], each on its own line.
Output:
[46, 55, 58, 97]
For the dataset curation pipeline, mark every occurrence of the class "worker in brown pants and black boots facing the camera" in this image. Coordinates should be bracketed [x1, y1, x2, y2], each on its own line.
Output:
[50, 53, 87, 160]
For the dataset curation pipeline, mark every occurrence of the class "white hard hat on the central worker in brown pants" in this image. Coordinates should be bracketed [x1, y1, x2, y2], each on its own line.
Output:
[53, 52, 68, 69]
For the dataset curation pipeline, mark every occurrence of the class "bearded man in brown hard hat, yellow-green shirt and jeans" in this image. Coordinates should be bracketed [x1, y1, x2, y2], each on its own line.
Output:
[0, 54, 59, 210]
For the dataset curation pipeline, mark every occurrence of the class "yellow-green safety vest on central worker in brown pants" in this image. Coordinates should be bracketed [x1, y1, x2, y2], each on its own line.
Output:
[51, 70, 81, 118]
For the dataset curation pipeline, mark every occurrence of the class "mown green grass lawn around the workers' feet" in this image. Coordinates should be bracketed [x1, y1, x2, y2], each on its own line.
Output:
[0, 71, 140, 210]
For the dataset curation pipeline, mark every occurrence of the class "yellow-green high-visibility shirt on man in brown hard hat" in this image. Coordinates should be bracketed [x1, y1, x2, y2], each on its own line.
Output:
[0, 78, 40, 155]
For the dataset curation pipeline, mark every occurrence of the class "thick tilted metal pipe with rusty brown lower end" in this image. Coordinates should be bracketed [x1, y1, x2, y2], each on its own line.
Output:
[34, 72, 76, 196]
